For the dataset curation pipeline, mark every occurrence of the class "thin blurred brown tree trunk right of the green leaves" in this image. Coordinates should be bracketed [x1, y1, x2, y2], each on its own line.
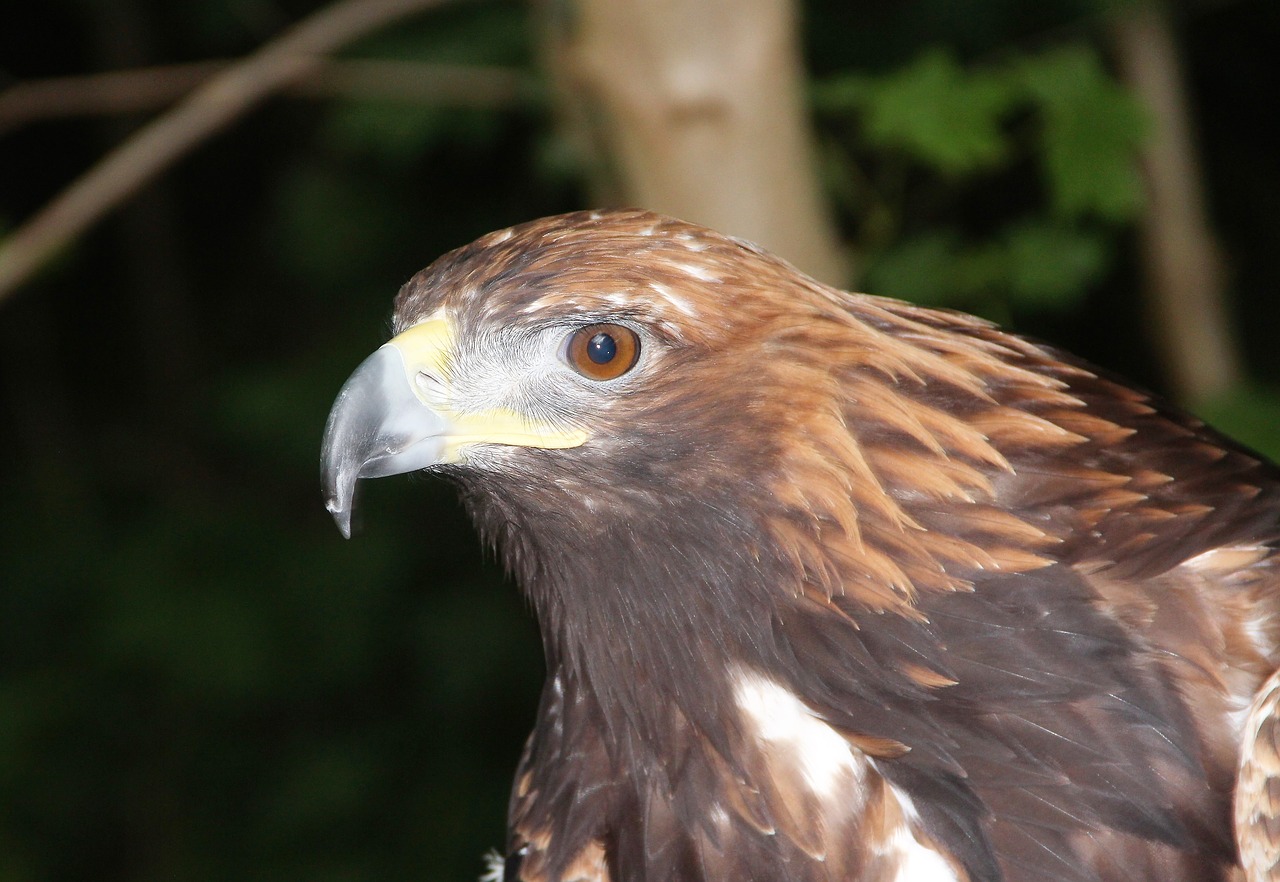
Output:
[1114, 3, 1243, 402]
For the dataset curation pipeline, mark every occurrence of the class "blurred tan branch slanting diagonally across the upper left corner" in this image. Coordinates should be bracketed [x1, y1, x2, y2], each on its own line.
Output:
[0, 0, 476, 301]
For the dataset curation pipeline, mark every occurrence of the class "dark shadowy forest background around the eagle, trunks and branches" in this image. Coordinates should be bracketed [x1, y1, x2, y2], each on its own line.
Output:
[0, 0, 1280, 882]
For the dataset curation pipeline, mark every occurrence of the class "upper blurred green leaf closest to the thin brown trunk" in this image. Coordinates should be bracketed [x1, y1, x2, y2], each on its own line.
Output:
[1020, 46, 1148, 221]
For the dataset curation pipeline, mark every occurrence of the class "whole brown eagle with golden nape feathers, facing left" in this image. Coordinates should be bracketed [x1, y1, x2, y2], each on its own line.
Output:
[323, 210, 1280, 882]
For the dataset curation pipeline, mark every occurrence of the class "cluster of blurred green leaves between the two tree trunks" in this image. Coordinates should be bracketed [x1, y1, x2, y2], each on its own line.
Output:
[814, 42, 1144, 315]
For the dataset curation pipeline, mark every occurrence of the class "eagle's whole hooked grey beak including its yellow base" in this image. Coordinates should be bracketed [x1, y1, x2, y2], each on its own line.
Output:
[320, 312, 588, 539]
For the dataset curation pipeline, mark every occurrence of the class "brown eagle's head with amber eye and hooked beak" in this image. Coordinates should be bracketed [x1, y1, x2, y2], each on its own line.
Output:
[324, 211, 847, 533]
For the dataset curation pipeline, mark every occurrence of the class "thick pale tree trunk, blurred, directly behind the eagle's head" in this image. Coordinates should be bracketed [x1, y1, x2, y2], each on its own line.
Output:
[548, 0, 849, 283]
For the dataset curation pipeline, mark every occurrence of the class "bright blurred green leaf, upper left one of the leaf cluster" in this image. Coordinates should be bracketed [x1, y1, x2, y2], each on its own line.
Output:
[844, 51, 1016, 174]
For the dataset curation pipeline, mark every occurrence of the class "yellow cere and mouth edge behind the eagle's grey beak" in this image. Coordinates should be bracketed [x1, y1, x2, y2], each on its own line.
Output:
[389, 311, 590, 462]
